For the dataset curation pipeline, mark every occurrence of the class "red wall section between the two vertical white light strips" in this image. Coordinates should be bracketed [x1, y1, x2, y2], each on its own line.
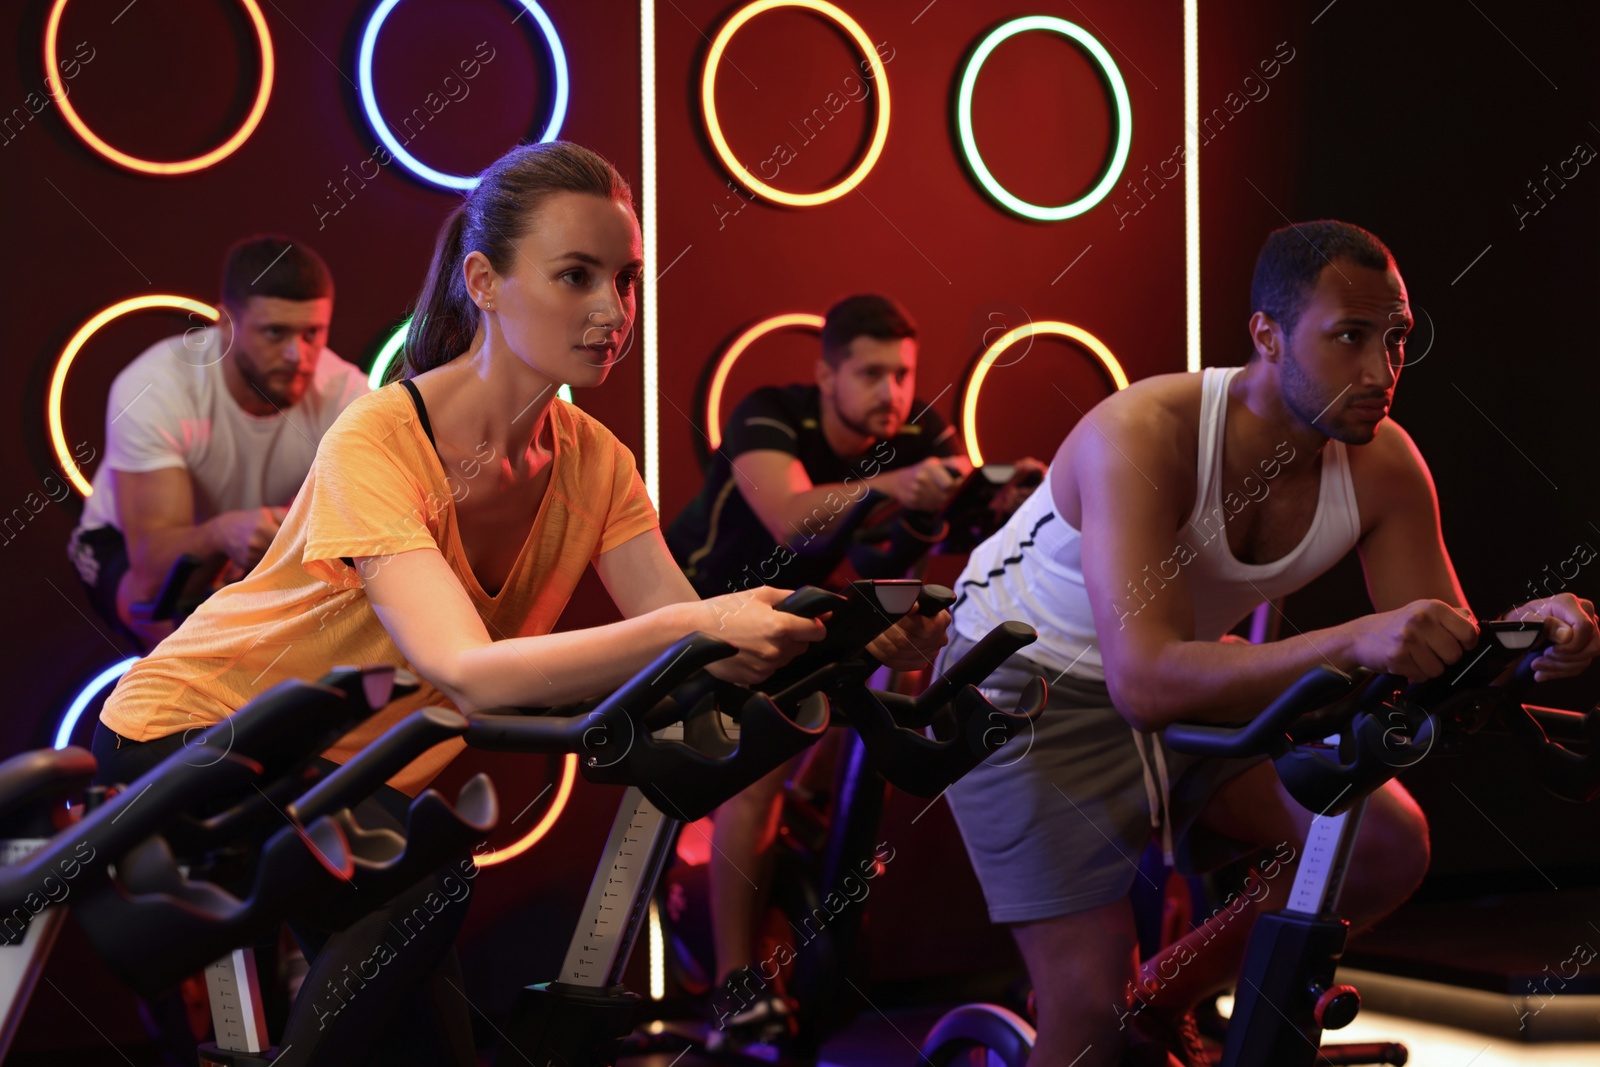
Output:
[658, 0, 1184, 514]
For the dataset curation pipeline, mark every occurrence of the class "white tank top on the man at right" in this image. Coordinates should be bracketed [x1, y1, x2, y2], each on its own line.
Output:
[955, 366, 1362, 681]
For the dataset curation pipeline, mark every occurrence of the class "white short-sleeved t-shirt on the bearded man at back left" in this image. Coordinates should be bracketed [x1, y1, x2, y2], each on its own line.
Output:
[78, 326, 368, 530]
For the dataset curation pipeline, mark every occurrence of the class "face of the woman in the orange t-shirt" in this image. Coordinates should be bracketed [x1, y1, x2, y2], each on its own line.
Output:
[488, 192, 643, 386]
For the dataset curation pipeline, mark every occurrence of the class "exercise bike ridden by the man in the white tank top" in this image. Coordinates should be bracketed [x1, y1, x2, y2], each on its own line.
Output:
[918, 622, 1600, 1067]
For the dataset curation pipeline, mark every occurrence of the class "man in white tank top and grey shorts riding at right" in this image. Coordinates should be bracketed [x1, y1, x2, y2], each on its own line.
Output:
[941, 222, 1600, 1067]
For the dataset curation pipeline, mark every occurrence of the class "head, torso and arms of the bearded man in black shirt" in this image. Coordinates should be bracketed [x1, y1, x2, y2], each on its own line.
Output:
[667, 296, 966, 597]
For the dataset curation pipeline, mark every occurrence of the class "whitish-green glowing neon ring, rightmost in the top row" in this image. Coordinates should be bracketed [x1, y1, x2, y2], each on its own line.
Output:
[955, 14, 1133, 222]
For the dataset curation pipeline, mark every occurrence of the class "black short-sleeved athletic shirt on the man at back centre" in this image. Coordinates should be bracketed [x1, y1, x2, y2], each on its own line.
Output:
[667, 386, 960, 597]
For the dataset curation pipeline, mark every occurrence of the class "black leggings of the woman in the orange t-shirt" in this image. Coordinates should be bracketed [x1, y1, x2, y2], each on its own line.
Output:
[91, 723, 477, 1067]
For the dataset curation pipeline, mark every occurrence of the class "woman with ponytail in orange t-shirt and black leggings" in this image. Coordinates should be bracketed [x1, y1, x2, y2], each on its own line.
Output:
[94, 142, 947, 1067]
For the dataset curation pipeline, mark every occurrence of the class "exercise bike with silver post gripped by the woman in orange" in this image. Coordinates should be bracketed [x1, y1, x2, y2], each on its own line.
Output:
[469, 581, 1045, 1067]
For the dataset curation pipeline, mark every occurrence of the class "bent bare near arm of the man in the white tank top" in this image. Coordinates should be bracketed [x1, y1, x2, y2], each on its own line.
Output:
[1075, 402, 1475, 729]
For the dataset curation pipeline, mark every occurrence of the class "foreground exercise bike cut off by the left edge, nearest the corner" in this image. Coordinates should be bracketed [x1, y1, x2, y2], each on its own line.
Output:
[0, 667, 448, 1057]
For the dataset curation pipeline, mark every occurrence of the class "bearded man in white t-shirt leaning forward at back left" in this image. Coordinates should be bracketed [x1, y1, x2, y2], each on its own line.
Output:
[67, 237, 366, 651]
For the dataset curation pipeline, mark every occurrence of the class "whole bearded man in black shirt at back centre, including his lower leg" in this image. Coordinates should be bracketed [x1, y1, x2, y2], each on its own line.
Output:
[667, 296, 970, 1049]
